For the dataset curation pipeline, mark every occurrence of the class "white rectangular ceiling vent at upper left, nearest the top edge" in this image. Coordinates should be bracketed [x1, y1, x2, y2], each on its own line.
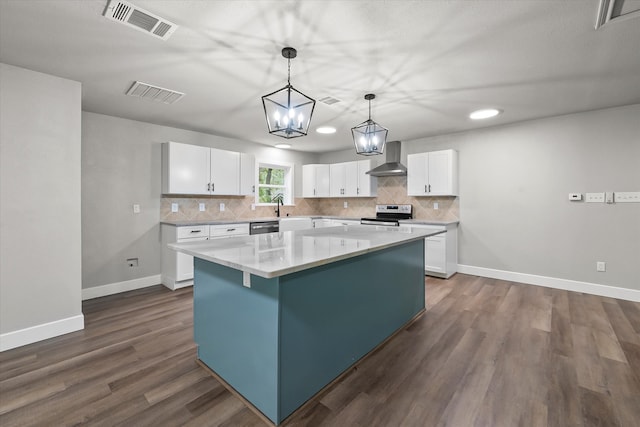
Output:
[104, 0, 178, 40]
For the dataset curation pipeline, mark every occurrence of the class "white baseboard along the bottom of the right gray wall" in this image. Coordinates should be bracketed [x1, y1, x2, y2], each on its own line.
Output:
[458, 264, 640, 302]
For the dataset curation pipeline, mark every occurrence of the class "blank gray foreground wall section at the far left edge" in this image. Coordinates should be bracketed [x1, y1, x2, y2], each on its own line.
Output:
[0, 64, 82, 334]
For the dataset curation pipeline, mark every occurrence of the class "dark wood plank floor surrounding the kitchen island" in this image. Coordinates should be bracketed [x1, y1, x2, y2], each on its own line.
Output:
[0, 274, 640, 427]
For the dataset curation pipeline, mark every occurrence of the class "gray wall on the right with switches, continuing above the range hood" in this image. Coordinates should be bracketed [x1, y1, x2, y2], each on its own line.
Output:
[319, 105, 640, 290]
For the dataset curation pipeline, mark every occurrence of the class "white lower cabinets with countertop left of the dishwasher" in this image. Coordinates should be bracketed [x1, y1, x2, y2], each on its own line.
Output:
[160, 223, 249, 290]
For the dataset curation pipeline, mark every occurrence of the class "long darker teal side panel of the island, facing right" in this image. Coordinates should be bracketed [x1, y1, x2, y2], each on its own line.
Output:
[278, 240, 425, 422]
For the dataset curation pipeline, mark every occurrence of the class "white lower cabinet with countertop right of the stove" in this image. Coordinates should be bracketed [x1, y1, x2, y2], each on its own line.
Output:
[411, 224, 458, 279]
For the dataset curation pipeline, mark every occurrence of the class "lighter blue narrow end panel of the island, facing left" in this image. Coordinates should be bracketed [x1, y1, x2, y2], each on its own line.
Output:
[193, 258, 278, 423]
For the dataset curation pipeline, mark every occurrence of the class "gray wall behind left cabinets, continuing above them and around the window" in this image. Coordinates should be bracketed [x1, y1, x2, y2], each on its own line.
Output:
[82, 112, 317, 288]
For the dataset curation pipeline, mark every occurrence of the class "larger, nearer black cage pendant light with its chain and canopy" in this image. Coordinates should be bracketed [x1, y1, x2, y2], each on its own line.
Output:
[262, 47, 316, 139]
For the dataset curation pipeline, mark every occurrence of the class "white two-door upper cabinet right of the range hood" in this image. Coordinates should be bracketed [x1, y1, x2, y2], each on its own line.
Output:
[407, 150, 458, 196]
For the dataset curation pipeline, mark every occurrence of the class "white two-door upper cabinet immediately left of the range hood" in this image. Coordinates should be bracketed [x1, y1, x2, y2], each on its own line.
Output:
[329, 160, 378, 197]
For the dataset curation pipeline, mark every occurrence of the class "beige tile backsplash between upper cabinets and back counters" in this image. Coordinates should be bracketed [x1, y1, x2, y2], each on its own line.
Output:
[160, 176, 460, 221]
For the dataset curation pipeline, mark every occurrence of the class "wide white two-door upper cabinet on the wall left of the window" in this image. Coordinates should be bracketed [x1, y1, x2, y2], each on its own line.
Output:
[162, 142, 240, 195]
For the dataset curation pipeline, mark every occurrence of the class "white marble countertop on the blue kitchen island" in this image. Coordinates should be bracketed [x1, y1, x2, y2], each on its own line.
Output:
[169, 225, 444, 278]
